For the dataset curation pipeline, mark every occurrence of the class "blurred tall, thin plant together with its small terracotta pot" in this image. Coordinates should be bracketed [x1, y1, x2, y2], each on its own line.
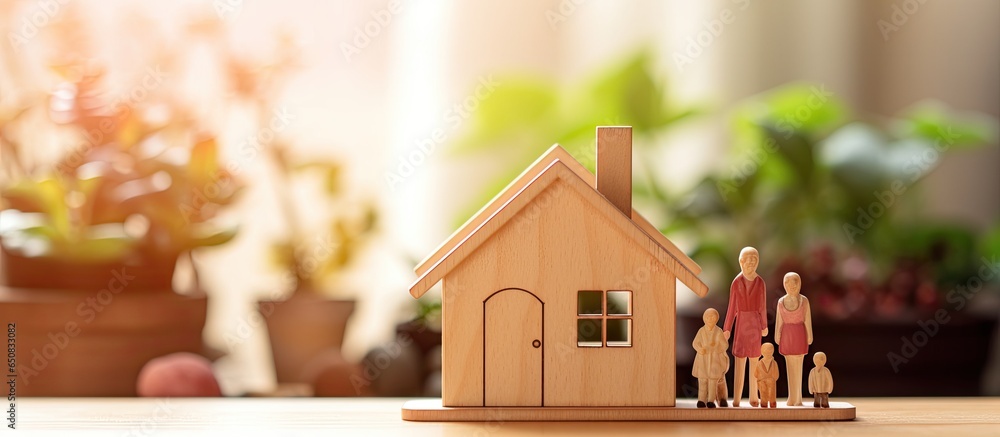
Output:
[186, 29, 377, 384]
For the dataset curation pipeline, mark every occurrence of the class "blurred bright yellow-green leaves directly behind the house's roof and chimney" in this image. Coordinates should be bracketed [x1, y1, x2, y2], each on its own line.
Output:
[451, 51, 699, 225]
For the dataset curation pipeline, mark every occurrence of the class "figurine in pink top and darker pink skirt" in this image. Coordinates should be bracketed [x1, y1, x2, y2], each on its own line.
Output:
[774, 272, 812, 406]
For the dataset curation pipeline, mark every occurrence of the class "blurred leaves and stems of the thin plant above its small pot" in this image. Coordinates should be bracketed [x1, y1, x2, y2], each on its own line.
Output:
[219, 39, 378, 293]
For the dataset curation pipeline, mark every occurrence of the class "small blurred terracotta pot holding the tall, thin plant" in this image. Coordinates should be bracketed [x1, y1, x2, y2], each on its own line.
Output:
[257, 292, 355, 383]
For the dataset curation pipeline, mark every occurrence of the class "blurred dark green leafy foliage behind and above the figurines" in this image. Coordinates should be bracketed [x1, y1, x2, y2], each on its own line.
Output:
[676, 84, 996, 285]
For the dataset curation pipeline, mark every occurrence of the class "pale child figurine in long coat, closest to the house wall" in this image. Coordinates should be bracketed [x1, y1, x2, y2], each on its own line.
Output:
[691, 308, 729, 408]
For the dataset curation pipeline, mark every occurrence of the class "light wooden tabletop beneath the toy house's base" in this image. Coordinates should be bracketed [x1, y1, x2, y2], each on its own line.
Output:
[15, 398, 1000, 437]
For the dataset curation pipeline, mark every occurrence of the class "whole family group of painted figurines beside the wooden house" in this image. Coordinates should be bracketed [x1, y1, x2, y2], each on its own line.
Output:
[691, 247, 833, 408]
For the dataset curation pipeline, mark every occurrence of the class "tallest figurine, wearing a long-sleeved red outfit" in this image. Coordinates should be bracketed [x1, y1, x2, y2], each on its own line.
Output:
[722, 247, 767, 407]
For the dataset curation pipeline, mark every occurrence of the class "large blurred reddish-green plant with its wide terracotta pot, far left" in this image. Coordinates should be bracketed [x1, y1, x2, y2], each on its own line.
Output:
[0, 67, 241, 396]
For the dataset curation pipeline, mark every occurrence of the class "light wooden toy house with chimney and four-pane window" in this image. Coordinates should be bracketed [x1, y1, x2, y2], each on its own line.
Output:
[410, 127, 708, 407]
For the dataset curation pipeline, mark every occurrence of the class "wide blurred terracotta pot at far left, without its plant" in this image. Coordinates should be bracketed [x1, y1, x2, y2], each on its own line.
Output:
[0, 284, 207, 396]
